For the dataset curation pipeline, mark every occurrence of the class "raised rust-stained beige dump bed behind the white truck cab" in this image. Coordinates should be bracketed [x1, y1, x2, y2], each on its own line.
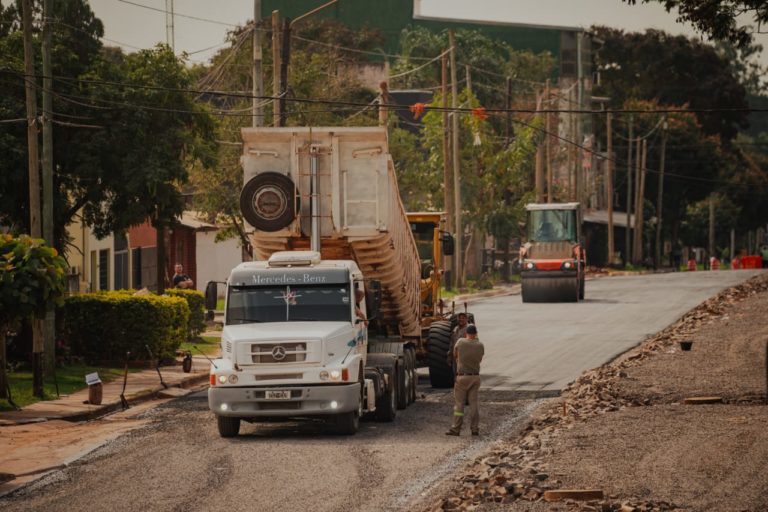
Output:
[240, 127, 421, 337]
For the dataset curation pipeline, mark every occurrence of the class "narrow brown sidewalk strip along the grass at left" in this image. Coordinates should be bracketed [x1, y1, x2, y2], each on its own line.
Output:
[0, 357, 210, 428]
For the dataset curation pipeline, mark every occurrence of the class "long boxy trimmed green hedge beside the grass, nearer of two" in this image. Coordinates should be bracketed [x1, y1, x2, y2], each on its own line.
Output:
[61, 291, 189, 362]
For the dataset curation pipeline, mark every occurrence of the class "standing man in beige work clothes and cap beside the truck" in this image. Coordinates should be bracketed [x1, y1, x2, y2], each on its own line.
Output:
[445, 324, 485, 436]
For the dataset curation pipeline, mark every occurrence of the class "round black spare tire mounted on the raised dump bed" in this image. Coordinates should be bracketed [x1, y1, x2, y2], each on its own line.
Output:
[240, 172, 299, 232]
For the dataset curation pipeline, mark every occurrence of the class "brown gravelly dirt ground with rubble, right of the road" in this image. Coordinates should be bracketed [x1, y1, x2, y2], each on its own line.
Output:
[430, 275, 768, 512]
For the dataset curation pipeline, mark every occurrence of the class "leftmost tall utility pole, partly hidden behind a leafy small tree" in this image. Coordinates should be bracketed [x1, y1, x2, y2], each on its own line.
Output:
[21, 0, 44, 398]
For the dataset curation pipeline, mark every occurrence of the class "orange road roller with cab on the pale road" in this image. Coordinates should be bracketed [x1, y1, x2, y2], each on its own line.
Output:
[519, 203, 587, 302]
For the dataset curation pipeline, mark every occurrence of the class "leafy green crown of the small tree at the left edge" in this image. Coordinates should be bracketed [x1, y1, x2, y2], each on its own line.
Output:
[0, 235, 67, 329]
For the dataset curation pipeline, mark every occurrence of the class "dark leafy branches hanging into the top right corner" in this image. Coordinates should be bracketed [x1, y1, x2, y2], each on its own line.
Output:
[624, 0, 768, 47]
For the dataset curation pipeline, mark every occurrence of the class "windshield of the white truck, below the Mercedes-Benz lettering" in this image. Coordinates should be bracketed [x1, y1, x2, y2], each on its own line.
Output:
[227, 284, 352, 324]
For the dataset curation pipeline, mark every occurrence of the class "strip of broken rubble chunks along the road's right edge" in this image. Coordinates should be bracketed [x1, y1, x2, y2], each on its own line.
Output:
[429, 276, 768, 512]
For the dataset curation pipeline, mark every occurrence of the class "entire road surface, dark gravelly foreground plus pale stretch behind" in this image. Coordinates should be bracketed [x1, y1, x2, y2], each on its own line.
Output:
[0, 271, 753, 512]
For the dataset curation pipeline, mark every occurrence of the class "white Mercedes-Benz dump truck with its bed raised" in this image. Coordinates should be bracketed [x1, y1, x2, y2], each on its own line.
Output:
[206, 127, 464, 437]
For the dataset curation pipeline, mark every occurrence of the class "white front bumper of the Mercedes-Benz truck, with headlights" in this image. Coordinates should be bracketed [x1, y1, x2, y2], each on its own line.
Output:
[208, 382, 360, 418]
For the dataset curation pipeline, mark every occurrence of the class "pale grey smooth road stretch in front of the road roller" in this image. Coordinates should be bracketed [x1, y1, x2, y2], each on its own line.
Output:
[472, 270, 762, 391]
